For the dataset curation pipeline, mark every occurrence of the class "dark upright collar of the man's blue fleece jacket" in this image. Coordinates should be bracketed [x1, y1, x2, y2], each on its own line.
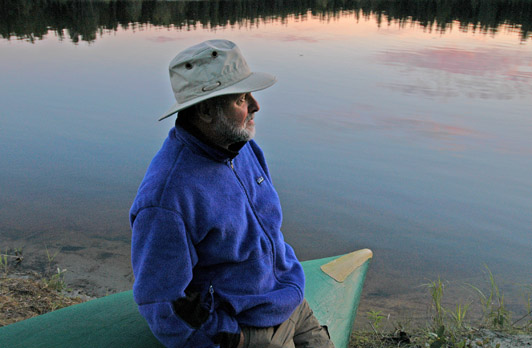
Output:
[175, 118, 247, 162]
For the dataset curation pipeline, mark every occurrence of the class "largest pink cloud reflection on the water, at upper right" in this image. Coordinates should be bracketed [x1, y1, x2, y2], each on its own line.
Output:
[378, 46, 532, 100]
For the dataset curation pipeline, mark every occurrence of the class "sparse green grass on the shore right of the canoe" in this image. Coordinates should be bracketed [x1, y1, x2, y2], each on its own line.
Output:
[350, 267, 532, 348]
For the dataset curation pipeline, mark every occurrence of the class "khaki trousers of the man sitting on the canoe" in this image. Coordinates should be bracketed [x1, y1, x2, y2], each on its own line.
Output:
[242, 300, 334, 348]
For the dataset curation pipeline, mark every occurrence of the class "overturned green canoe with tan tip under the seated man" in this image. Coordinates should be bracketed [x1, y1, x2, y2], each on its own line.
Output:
[0, 249, 372, 348]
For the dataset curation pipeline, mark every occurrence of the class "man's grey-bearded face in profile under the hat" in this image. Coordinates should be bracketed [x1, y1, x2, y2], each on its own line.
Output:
[214, 93, 260, 144]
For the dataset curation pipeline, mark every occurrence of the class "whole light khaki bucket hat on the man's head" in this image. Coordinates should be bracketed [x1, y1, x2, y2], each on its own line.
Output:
[159, 40, 277, 121]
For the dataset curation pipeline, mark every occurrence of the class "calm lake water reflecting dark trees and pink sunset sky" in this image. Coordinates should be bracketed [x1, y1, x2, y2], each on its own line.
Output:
[0, 0, 532, 315]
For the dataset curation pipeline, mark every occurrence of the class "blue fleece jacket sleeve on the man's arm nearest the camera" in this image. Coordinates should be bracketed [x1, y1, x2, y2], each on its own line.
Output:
[131, 207, 240, 348]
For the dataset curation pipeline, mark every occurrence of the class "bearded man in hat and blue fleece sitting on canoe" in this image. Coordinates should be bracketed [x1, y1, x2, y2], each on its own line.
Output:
[130, 40, 332, 348]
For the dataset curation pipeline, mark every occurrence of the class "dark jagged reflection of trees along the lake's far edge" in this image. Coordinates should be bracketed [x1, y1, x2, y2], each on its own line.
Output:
[0, 0, 532, 42]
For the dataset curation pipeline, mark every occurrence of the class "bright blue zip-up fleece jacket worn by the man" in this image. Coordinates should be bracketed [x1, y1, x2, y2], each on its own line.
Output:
[130, 124, 304, 348]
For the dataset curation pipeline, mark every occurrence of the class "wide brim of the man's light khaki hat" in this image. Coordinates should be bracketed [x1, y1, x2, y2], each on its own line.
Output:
[159, 72, 277, 121]
